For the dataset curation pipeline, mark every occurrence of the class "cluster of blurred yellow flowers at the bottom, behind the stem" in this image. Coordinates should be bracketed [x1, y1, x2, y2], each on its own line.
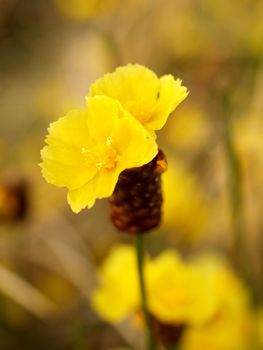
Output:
[92, 245, 252, 350]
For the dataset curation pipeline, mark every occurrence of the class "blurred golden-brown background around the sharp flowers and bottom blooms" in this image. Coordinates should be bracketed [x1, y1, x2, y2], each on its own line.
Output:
[0, 0, 263, 350]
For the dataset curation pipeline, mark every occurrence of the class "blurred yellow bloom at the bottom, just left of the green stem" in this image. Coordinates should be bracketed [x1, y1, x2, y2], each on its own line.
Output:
[91, 245, 140, 322]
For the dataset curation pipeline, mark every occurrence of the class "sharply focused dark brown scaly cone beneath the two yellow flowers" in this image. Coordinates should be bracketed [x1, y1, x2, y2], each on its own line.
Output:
[110, 150, 167, 234]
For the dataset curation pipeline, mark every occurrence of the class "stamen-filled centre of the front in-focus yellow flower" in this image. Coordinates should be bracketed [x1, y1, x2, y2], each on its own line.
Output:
[81, 137, 118, 170]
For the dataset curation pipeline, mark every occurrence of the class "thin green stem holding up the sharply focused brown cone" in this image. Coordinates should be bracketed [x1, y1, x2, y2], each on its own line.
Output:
[135, 234, 156, 350]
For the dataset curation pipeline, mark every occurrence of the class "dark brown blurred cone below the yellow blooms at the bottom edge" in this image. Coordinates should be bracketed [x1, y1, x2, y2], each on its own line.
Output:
[152, 317, 185, 347]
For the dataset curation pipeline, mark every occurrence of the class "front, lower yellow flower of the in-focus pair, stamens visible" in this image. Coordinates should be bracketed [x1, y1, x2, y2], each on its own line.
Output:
[40, 96, 157, 213]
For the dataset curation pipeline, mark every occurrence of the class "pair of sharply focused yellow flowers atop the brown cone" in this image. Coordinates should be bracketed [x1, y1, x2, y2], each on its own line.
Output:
[40, 64, 188, 213]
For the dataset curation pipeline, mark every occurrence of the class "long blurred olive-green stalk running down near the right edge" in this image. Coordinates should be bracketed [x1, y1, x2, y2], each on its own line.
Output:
[222, 60, 262, 305]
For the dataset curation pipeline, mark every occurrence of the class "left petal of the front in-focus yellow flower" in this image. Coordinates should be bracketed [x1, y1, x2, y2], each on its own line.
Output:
[40, 110, 97, 189]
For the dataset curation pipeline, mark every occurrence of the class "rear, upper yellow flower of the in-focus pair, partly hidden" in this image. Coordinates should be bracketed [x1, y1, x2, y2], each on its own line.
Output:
[89, 64, 188, 131]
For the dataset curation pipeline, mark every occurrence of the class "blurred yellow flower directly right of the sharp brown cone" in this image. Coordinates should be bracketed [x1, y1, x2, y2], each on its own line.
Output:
[163, 159, 211, 242]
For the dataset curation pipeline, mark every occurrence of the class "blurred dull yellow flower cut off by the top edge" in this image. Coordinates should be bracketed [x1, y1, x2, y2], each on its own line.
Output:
[55, 0, 118, 21]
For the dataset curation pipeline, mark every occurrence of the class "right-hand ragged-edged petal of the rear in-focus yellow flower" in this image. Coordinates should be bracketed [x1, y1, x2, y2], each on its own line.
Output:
[147, 75, 188, 130]
